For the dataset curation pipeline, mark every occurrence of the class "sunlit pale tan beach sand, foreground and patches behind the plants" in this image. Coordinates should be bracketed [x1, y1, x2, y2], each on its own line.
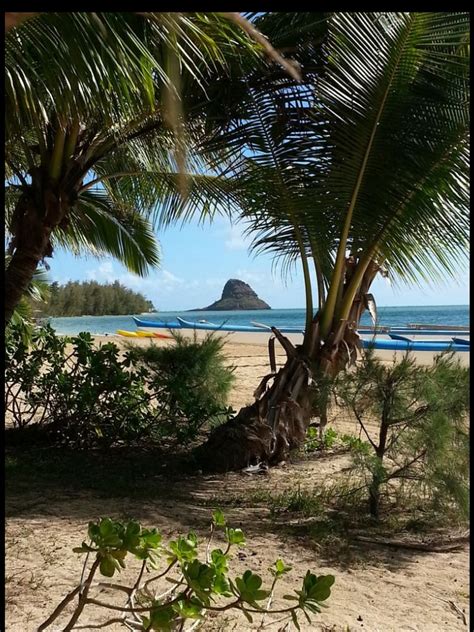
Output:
[6, 336, 469, 632]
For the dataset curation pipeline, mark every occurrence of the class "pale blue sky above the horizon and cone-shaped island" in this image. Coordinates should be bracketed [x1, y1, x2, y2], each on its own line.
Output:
[48, 217, 469, 311]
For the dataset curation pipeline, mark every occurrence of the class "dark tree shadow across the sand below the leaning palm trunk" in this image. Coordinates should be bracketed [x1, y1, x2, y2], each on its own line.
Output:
[6, 446, 466, 571]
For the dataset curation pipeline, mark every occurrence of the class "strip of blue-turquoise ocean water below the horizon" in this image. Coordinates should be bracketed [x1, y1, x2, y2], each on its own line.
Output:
[49, 305, 469, 335]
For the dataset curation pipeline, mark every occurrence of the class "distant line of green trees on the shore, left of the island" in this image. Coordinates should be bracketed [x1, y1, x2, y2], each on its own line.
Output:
[42, 281, 154, 316]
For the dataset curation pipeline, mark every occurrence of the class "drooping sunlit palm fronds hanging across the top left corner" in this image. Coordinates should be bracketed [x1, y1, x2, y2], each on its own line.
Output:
[6, 12, 261, 136]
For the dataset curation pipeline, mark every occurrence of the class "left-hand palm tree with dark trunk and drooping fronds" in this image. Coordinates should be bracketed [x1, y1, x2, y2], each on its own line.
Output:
[5, 13, 282, 323]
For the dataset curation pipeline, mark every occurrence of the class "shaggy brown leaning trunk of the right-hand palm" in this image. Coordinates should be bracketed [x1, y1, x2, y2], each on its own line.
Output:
[195, 264, 378, 472]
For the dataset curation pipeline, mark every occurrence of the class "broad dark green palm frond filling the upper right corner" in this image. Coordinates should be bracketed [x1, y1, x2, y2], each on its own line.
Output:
[316, 13, 469, 280]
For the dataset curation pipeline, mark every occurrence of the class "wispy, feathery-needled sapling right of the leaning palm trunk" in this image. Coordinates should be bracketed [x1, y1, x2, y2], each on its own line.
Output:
[337, 352, 469, 516]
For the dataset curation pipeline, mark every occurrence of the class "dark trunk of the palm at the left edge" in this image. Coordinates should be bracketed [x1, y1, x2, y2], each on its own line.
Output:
[5, 194, 56, 326]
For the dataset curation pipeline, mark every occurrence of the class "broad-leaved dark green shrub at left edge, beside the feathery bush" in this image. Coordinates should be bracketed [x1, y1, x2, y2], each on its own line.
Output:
[6, 326, 153, 448]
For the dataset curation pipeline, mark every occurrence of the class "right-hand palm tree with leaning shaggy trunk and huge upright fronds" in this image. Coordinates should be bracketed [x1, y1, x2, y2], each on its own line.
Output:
[187, 12, 469, 469]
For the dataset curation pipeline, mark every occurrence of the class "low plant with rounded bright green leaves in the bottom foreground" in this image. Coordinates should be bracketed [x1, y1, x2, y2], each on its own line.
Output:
[40, 511, 334, 632]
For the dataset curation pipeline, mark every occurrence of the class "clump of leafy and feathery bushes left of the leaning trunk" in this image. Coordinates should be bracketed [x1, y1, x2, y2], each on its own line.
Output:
[5, 326, 233, 448]
